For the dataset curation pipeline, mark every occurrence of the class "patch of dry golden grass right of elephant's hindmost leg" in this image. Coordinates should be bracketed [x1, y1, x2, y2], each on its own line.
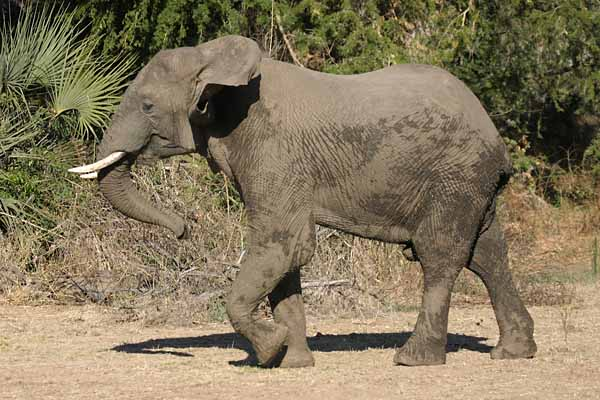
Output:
[500, 175, 600, 305]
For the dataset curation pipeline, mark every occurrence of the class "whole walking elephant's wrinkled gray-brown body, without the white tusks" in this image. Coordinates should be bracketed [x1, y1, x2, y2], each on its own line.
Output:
[99, 36, 536, 367]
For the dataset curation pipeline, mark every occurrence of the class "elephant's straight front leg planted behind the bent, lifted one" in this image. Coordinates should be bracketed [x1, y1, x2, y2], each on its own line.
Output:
[269, 268, 315, 368]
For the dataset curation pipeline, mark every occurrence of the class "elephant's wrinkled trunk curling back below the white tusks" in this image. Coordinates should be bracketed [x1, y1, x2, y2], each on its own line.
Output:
[98, 159, 186, 238]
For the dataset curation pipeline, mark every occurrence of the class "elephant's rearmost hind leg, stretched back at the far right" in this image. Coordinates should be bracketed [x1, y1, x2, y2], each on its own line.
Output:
[468, 219, 537, 359]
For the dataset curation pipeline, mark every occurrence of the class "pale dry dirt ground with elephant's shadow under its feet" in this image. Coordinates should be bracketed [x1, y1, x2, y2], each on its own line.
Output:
[0, 285, 600, 400]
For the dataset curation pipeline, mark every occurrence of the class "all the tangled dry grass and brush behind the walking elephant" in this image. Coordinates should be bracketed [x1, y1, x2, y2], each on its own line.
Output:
[0, 158, 600, 324]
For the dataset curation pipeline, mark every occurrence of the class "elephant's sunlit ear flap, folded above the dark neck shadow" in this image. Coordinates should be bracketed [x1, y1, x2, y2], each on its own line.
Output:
[196, 36, 262, 87]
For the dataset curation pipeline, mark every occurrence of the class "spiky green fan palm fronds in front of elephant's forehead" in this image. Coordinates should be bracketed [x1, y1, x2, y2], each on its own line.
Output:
[0, 6, 135, 138]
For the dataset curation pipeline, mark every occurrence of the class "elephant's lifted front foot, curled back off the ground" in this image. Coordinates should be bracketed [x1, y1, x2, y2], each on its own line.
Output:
[248, 321, 288, 366]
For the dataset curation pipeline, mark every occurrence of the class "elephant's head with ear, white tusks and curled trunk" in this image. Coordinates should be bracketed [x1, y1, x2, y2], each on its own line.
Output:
[70, 36, 261, 237]
